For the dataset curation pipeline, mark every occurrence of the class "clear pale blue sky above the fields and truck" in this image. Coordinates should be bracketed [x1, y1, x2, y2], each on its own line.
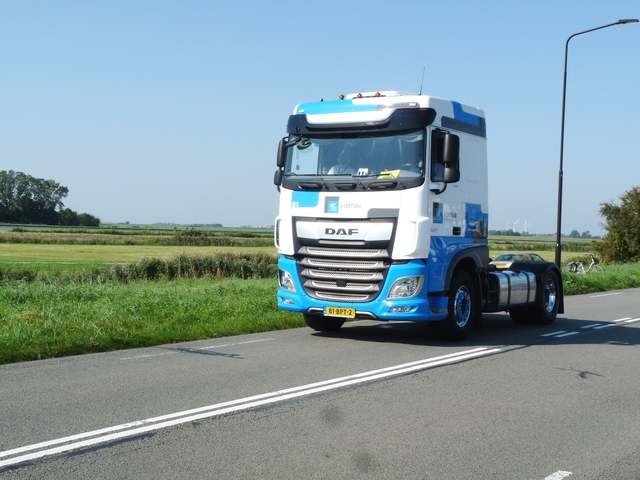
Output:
[0, 0, 640, 234]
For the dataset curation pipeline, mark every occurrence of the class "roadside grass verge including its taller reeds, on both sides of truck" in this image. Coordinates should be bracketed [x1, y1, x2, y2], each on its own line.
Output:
[0, 252, 640, 364]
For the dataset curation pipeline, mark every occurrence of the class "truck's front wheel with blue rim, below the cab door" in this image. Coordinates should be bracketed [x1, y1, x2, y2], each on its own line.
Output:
[430, 270, 477, 341]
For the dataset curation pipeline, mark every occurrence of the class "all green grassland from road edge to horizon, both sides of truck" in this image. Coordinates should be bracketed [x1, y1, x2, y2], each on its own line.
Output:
[0, 231, 640, 363]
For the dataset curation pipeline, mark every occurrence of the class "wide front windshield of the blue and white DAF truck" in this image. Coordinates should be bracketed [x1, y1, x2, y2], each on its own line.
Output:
[284, 130, 425, 180]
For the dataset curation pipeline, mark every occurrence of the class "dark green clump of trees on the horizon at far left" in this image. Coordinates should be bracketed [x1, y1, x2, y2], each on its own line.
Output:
[0, 170, 100, 227]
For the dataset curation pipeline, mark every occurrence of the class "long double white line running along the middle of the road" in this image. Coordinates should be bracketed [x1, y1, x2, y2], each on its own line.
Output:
[0, 347, 501, 467]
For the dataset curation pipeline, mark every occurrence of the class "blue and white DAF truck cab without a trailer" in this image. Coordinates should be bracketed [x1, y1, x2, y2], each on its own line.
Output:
[274, 91, 564, 340]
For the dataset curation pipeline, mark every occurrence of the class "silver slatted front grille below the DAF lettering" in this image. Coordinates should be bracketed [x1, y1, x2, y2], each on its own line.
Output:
[298, 246, 389, 302]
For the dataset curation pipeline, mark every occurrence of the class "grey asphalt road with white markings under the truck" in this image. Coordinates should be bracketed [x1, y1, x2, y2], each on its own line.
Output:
[0, 289, 640, 480]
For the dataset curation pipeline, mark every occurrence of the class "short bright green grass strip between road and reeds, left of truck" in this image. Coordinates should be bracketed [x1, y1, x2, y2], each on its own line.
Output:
[0, 278, 304, 364]
